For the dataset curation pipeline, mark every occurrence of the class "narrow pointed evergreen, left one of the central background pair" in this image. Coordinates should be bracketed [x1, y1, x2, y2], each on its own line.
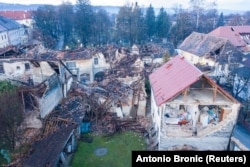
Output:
[145, 4, 155, 39]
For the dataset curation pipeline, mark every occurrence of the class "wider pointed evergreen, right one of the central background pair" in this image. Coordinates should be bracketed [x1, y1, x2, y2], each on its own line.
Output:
[156, 7, 170, 38]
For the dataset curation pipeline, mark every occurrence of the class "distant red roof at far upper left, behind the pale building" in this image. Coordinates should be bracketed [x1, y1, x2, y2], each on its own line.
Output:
[0, 11, 32, 20]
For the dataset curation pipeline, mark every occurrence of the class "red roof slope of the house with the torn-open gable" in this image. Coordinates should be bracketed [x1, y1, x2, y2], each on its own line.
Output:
[149, 55, 203, 105]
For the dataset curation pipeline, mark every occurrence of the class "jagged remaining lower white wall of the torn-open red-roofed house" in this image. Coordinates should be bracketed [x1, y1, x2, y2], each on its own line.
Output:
[159, 103, 240, 150]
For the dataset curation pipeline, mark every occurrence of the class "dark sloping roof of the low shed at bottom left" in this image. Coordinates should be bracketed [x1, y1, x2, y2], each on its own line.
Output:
[24, 124, 76, 167]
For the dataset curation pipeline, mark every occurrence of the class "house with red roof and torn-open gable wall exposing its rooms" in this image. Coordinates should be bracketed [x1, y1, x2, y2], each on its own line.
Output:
[149, 55, 240, 150]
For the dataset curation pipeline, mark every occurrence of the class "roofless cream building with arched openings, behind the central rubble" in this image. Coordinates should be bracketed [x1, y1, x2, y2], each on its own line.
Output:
[41, 49, 109, 83]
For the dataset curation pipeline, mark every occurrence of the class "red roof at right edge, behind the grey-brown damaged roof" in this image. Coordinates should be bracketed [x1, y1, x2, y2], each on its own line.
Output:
[209, 26, 250, 47]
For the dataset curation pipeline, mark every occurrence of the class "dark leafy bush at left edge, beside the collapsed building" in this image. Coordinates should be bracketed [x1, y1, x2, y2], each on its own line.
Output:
[0, 81, 23, 151]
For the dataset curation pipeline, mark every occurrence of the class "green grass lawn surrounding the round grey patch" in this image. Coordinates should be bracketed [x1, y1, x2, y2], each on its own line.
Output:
[71, 132, 146, 167]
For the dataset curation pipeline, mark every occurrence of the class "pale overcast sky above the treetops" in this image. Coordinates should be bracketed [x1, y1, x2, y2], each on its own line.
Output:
[0, 0, 250, 10]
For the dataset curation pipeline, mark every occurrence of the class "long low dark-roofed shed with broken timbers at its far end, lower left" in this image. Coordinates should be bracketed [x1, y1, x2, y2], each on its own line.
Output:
[22, 88, 91, 167]
